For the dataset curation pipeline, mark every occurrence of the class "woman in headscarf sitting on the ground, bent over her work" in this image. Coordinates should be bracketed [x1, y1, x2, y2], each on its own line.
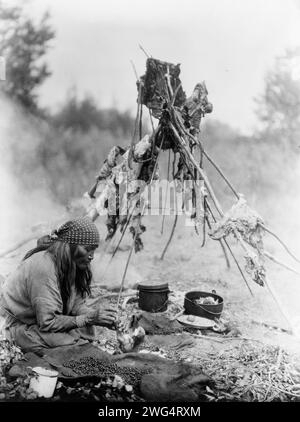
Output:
[0, 217, 116, 352]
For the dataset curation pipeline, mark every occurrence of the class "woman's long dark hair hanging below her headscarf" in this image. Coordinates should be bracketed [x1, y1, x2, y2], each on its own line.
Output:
[24, 241, 92, 313]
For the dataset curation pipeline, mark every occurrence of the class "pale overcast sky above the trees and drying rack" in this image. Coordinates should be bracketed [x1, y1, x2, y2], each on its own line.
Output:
[18, 0, 300, 133]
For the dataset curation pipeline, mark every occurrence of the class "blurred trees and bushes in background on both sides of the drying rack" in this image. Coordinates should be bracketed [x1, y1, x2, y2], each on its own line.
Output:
[0, 2, 300, 208]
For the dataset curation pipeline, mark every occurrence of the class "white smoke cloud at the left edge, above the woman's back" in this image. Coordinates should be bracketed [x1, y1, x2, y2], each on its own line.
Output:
[0, 95, 64, 251]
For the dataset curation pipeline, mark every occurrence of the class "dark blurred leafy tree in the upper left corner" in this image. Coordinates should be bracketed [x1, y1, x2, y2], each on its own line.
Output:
[0, 1, 54, 112]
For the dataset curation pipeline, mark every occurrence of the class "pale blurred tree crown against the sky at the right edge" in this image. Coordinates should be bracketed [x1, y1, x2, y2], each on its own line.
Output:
[257, 49, 300, 151]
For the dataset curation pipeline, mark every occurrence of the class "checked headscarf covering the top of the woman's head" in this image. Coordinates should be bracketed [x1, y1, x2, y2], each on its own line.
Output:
[51, 217, 100, 247]
